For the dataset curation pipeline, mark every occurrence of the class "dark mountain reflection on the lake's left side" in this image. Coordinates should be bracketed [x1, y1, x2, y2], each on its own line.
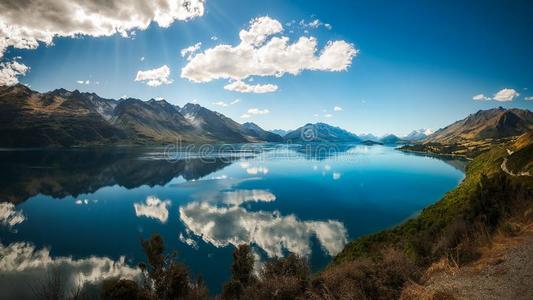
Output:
[0, 150, 232, 204]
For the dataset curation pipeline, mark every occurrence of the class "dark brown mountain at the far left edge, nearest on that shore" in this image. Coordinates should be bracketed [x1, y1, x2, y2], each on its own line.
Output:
[0, 84, 125, 147]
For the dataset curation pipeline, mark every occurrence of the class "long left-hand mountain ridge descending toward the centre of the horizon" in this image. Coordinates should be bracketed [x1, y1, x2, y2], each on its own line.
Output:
[0, 84, 282, 147]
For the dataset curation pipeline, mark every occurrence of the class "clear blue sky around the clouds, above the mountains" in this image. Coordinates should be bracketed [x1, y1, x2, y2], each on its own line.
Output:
[3, 0, 533, 134]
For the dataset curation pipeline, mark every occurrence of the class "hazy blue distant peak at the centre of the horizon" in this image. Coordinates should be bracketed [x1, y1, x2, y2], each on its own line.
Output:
[284, 123, 361, 143]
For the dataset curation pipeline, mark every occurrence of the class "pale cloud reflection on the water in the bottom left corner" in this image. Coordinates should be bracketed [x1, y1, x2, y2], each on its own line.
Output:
[0, 242, 141, 299]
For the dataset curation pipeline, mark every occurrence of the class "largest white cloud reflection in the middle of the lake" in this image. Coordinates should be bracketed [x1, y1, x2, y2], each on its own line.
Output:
[179, 190, 347, 257]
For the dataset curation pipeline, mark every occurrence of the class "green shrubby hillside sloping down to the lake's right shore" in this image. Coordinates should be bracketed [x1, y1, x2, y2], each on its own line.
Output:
[333, 139, 533, 266]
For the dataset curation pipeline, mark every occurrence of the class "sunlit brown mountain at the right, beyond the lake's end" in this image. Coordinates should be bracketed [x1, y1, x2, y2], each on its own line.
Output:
[423, 107, 533, 144]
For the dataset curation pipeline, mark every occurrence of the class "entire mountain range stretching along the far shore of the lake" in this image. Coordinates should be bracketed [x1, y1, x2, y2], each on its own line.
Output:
[0, 84, 533, 147]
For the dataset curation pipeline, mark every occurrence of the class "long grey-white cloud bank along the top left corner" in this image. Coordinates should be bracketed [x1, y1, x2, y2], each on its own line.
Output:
[0, 0, 204, 58]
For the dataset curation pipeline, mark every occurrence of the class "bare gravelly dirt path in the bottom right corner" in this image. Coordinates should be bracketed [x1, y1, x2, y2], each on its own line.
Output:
[424, 232, 533, 300]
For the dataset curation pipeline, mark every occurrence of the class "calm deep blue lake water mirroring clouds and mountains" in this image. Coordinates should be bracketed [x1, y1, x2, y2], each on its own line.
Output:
[0, 145, 463, 295]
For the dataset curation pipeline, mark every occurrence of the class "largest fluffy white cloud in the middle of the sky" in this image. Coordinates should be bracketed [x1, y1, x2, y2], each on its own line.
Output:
[181, 17, 358, 88]
